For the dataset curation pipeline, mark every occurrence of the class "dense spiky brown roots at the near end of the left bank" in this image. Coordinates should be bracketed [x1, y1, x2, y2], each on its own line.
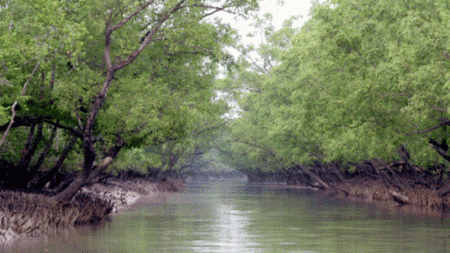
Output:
[0, 191, 112, 241]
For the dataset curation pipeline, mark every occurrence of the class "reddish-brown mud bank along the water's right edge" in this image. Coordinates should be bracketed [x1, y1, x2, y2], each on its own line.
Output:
[279, 175, 450, 217]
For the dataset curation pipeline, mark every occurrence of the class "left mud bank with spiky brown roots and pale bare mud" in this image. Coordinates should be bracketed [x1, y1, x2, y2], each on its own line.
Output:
[0, 178, 183, 246]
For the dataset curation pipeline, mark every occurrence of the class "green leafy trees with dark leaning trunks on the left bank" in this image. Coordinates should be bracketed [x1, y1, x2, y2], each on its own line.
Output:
[0, 0, 257, 200]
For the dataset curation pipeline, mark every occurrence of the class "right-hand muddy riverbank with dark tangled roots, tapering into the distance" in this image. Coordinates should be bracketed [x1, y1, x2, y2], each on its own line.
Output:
[243, 161, 450, 216]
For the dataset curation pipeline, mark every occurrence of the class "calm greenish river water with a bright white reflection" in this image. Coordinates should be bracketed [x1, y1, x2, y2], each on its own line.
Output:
[4, 182, 450, 252]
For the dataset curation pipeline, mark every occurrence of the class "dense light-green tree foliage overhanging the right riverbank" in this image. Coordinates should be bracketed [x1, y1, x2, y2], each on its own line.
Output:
[222, 0, 450, 177]
